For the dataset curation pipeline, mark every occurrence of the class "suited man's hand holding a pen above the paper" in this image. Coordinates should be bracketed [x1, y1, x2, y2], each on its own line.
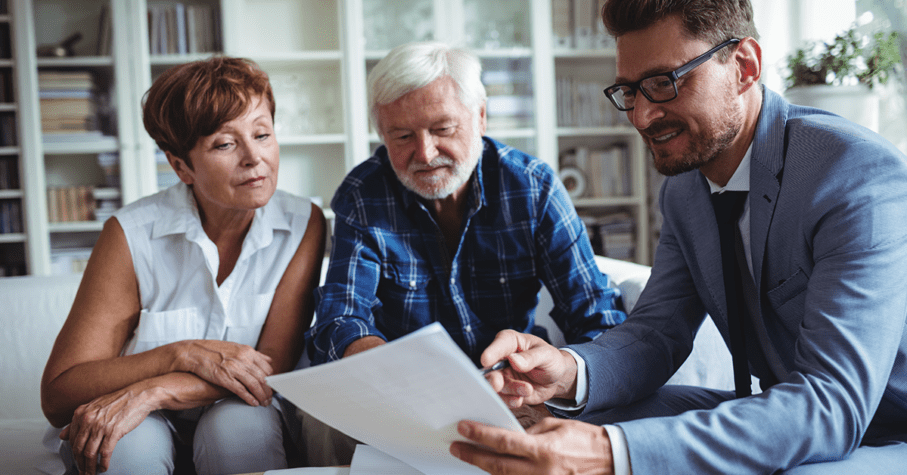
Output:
[481, 330, 576, 408]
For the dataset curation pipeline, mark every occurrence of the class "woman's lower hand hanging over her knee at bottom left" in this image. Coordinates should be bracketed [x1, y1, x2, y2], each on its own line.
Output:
[60, 386, 155, 475]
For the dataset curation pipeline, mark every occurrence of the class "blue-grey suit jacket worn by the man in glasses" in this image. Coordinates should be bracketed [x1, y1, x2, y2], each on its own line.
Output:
[571, 89, 907, 475]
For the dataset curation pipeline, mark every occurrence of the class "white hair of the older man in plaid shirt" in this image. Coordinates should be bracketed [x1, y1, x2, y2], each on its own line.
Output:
[368, 42, 486, 139]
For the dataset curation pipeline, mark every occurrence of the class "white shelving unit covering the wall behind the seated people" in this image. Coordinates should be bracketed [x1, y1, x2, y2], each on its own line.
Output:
[0, 0, 650, 274]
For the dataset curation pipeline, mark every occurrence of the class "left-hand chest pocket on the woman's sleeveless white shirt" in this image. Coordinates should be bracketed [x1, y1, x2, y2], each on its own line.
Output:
[133, 307, 207, 353]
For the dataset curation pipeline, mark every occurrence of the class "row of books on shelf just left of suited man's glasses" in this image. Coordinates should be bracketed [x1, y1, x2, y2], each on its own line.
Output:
[555, 75, 625, 127]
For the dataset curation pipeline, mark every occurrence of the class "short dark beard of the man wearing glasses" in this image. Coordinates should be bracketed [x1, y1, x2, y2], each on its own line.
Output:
[640, 88, 743, 176]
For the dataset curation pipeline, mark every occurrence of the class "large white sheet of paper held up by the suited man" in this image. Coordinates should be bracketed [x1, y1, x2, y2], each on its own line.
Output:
[268, 323, 523, 475]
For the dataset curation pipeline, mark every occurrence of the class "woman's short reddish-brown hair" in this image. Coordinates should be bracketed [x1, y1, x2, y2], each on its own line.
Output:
[142, 56, 274, 168]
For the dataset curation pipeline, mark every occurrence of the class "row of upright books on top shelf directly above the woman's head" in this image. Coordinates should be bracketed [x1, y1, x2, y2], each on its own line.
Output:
[148, 2, 221, 54]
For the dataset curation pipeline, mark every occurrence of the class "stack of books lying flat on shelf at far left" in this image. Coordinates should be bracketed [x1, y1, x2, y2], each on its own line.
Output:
[38, 70, 100, 137]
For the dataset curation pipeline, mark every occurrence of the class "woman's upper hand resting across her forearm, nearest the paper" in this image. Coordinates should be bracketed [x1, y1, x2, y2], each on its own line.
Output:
[180, 340, 274, 406]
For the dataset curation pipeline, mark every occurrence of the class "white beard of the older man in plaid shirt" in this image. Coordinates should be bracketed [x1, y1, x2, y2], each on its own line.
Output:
[392, 130, 485, 200]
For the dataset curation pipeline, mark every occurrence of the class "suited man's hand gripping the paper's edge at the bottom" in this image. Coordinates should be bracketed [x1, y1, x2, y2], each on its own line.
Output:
[450, 417, 614, 475]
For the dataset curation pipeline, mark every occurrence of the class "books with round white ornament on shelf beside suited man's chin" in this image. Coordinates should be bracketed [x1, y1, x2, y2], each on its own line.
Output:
[559, 145, 633, 199]
